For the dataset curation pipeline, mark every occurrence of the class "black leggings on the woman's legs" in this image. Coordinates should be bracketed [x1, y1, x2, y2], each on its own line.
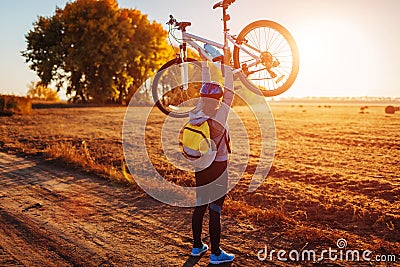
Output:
[192, 161, 228, 254]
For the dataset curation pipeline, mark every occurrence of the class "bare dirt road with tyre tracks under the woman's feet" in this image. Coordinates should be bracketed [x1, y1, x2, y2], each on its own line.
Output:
[0, 153, 272, 266]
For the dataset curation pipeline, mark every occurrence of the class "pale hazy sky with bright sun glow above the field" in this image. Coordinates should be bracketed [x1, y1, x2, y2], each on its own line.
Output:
[0, 0, 400, 98]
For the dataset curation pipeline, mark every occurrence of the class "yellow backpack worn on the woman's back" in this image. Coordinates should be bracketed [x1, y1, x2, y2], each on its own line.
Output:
[180, 120, 231, 164]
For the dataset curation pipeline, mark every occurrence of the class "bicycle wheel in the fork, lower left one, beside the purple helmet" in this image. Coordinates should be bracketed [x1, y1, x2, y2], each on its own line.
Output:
[152, 58, 202, 118]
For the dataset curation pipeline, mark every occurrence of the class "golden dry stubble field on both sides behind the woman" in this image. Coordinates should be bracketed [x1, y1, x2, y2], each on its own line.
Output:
[0, 104, 400, 260]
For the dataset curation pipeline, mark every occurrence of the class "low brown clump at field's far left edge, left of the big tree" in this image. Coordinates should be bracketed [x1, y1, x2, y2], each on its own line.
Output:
[0, 95, 32, 116]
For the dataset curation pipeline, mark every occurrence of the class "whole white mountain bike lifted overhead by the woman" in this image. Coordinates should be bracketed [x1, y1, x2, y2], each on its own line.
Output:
[152, 0, 299, 118]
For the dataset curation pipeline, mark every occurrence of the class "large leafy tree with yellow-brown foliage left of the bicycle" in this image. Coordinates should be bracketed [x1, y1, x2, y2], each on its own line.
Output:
[21, 0, 174, 104]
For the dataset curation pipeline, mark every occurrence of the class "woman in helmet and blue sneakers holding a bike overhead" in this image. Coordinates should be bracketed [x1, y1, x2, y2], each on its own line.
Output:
[190, 62, 235, 264]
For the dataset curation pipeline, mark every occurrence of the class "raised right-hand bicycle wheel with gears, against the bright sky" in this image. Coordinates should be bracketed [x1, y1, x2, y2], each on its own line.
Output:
[233, 20, 299, 96]
